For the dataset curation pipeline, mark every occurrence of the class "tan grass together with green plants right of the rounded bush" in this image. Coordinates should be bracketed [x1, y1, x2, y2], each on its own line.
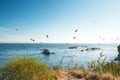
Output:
[54, 53, 120, 80]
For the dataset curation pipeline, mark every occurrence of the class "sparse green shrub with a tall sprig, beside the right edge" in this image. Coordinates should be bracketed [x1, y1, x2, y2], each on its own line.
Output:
[88, 52, 120, 76]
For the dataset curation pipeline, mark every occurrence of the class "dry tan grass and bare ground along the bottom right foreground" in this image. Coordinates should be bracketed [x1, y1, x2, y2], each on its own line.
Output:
[55, 69, 120, 80]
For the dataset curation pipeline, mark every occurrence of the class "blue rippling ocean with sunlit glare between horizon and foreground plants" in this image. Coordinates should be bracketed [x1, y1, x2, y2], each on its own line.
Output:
[0, 43, 118, 67]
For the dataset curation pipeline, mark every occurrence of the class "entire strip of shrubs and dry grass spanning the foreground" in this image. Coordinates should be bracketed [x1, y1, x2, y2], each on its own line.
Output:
[0, 53, 120, 80]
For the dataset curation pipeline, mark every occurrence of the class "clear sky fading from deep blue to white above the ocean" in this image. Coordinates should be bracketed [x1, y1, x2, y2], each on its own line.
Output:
[0, 0, 120, 43]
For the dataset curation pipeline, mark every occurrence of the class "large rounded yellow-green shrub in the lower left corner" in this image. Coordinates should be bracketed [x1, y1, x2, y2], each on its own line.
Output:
[0, 57, 53, 80]
